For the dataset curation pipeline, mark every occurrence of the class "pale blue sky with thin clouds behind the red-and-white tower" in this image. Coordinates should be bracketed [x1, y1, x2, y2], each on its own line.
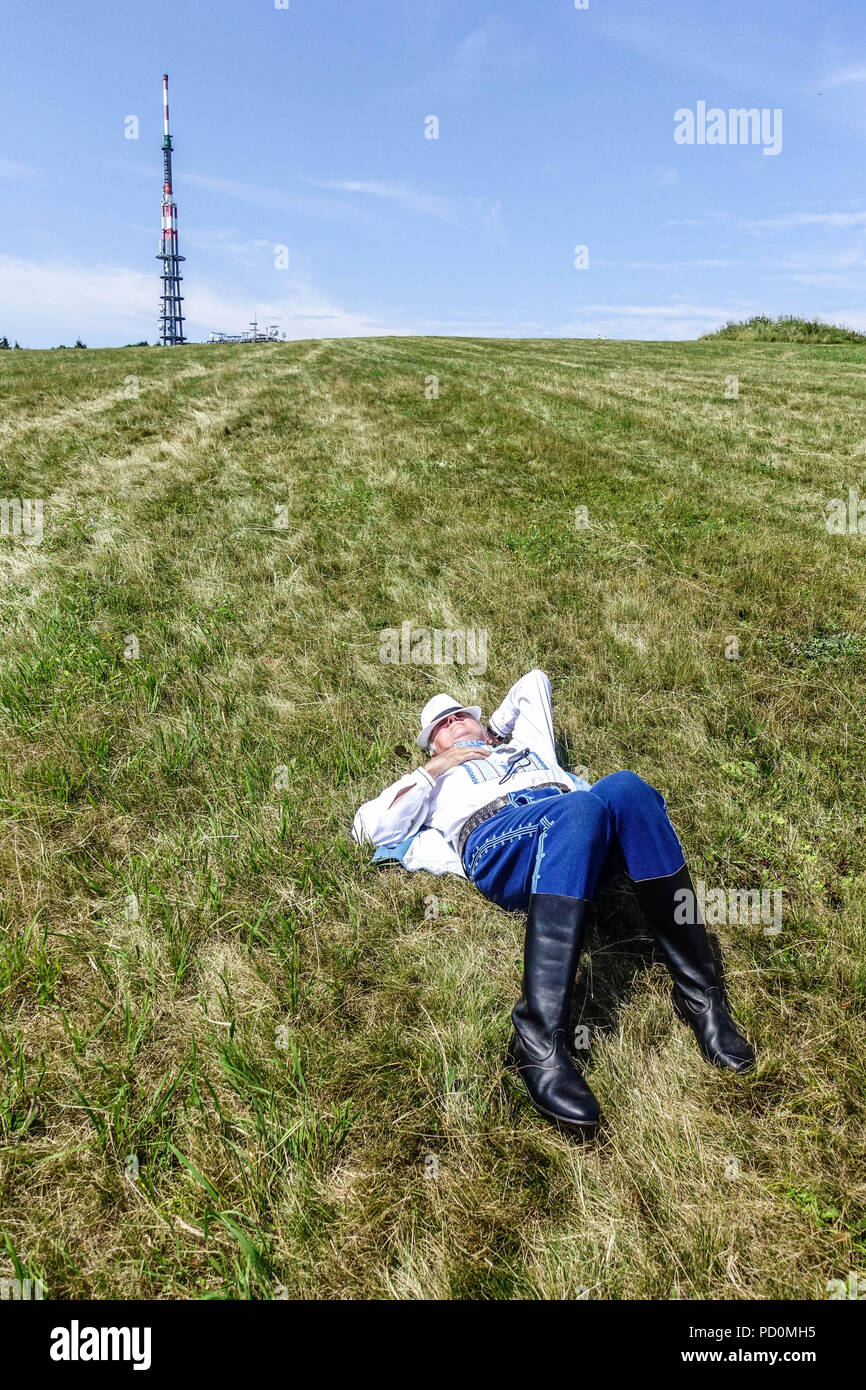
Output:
[0, 0, 866, 348]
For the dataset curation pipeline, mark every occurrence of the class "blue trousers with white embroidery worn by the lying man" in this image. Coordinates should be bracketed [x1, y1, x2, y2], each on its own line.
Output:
[463, 771, 685, 910]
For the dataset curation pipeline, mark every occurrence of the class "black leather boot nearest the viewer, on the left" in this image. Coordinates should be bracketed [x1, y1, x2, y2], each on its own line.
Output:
[507, 892, 599, 1137]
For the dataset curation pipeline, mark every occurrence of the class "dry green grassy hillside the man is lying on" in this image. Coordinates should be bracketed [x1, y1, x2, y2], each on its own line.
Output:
[0, 330, 866, 1300]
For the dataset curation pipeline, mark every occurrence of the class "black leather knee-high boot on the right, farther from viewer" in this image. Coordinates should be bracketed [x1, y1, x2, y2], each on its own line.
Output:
[632, 865, 755, 1072]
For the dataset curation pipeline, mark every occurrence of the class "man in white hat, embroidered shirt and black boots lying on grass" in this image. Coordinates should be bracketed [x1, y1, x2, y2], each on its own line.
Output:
[353, 670, 755, 1136]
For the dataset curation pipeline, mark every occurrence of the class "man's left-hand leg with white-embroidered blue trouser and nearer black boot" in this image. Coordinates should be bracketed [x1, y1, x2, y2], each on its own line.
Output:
[464, 791, 613, 1136]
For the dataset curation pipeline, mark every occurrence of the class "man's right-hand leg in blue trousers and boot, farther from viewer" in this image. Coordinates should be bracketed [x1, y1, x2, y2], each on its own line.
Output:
[589, 771, 755, 1072]
